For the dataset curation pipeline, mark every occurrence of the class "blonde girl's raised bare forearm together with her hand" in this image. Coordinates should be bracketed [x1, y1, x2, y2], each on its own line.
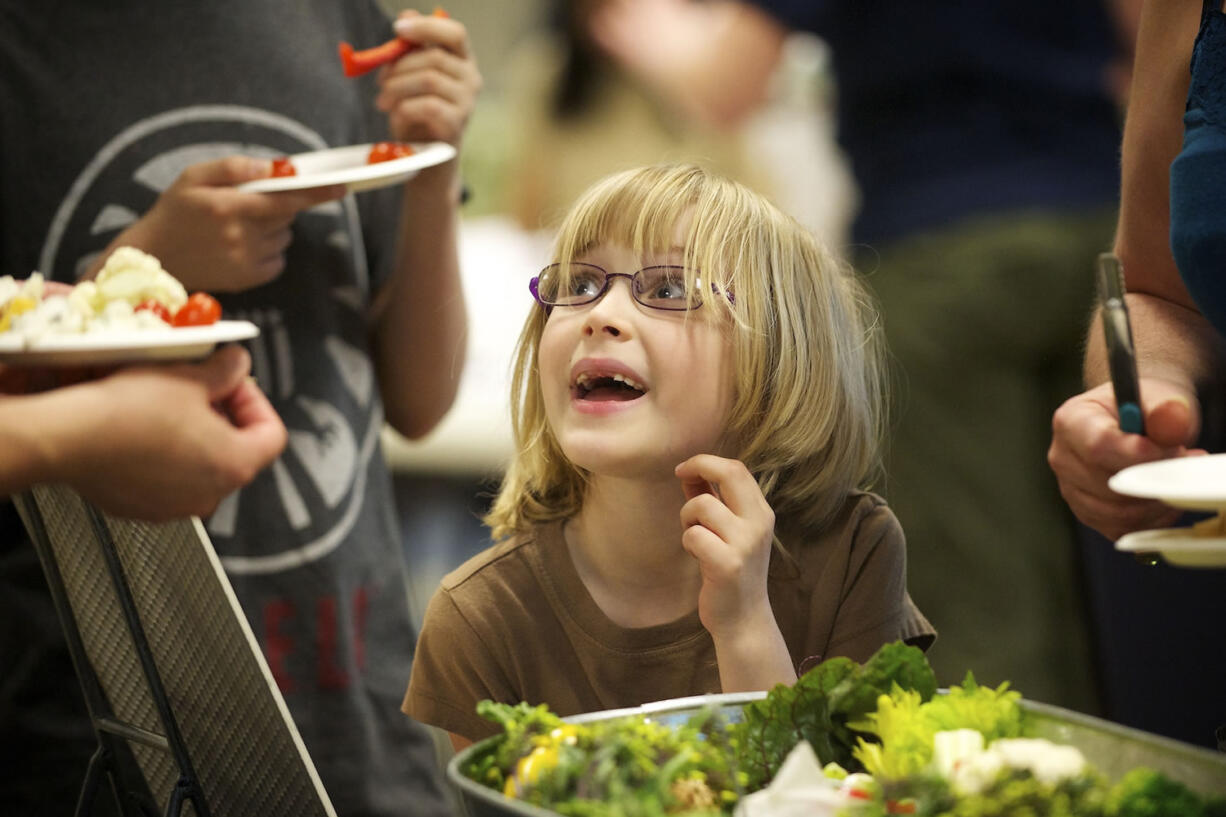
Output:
[677, 454, 796, 692]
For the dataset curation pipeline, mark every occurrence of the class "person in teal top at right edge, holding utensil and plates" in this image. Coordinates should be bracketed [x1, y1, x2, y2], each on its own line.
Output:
[1048, 0, 1226, 748]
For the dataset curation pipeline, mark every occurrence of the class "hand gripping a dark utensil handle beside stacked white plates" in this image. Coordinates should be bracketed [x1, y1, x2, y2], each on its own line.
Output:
[1047, 378, 1205, 540]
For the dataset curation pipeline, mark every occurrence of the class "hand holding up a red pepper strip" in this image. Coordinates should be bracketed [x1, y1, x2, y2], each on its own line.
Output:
[375, 10, 482, 146]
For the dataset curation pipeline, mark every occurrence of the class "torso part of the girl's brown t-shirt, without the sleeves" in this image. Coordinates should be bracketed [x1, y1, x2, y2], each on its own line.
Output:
[444, 498, 888, 715]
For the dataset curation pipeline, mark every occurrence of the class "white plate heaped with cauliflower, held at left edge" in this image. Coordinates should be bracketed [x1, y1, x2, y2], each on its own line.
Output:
[0, 320, 260, 366]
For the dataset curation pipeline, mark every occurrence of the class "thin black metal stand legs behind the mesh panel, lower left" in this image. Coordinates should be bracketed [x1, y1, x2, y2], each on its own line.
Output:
[23, 493, 211, 817]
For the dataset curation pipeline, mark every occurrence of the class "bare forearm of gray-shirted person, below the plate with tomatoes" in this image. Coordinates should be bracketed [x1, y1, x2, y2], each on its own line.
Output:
[374, 161, 467, 438]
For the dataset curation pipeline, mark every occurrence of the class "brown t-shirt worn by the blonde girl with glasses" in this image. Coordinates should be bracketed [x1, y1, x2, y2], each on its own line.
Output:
[403, 493, 935, 740]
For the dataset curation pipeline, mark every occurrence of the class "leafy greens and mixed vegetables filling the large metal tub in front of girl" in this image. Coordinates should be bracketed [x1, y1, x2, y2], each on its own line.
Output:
[460, 643, 1226, 817]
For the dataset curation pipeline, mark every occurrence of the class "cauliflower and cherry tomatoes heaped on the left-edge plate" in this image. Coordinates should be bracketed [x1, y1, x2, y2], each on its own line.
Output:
[0, 247, 221, 342]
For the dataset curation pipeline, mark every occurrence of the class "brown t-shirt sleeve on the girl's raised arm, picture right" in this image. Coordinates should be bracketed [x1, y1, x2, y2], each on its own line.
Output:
[828, 504, 937, 662]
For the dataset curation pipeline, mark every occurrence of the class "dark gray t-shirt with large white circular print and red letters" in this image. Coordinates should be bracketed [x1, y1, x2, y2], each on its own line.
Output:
[0, 0, 446, 817]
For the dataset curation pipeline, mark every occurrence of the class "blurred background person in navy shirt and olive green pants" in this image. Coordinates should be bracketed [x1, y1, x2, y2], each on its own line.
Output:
[592, 0, 1132, 713]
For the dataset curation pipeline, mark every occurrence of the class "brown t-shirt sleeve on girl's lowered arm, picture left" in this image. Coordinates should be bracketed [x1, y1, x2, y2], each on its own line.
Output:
[401, 579, 515, 740]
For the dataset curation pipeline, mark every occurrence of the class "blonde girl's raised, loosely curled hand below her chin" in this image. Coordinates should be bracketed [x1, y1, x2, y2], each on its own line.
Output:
[676, 454, 775, 640]
